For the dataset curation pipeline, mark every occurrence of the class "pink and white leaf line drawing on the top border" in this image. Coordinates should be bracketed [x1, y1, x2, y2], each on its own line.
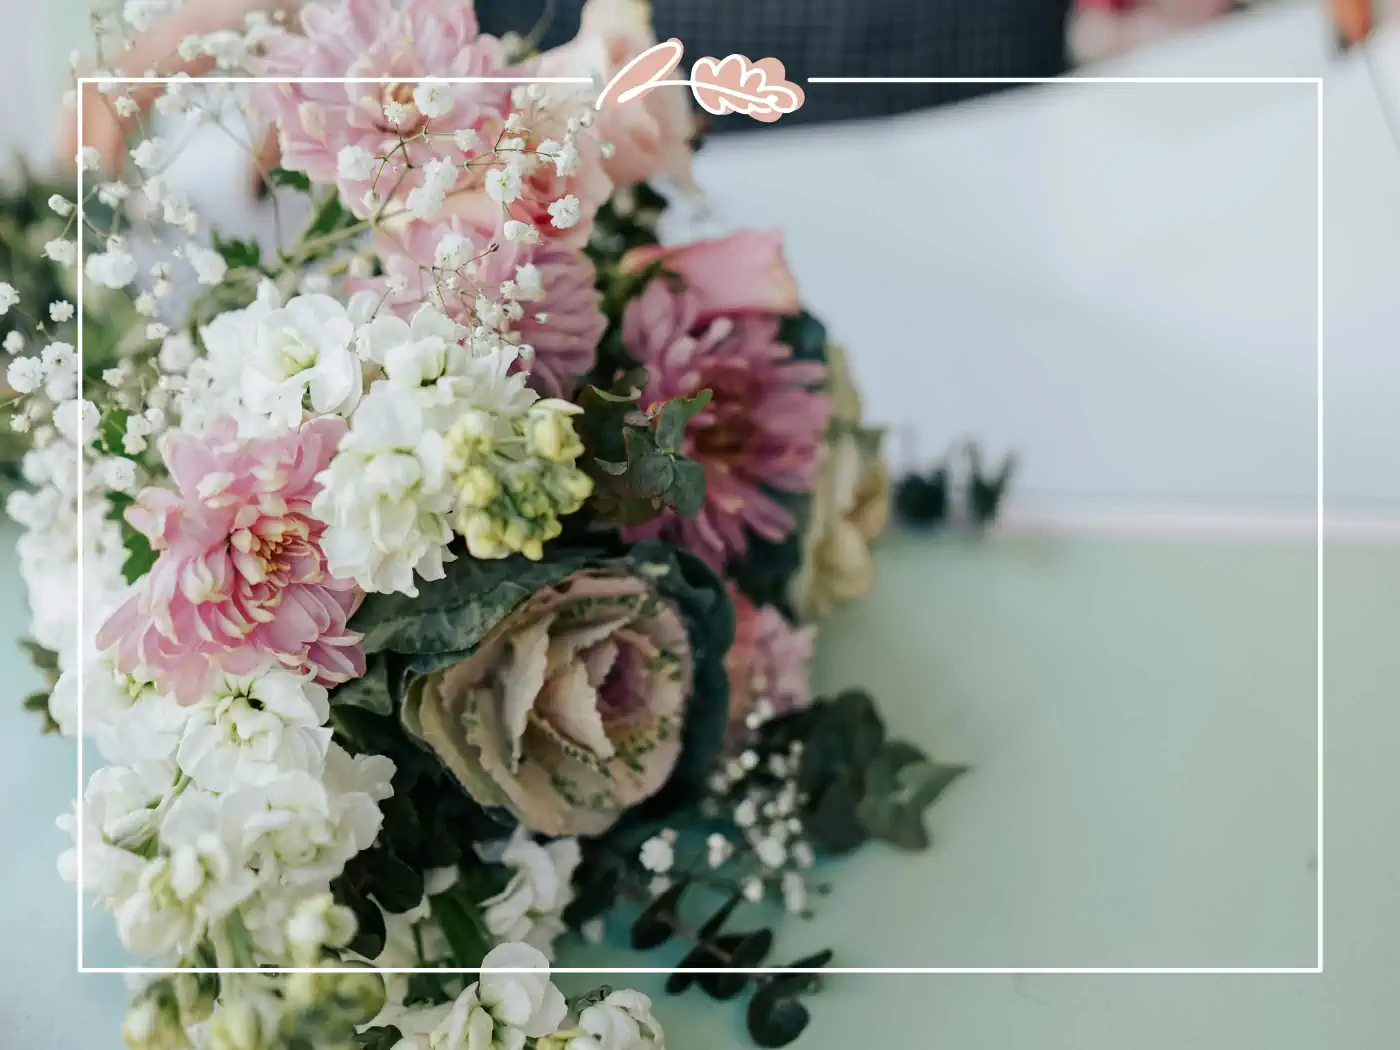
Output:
[595, 38, 806, 123]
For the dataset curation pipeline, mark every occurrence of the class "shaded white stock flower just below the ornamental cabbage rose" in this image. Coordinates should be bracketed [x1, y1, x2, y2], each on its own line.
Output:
[482, 825, 580, 958]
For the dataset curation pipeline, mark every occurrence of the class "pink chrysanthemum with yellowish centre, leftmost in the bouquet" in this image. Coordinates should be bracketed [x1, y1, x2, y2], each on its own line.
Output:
[97, 417, 364, 704]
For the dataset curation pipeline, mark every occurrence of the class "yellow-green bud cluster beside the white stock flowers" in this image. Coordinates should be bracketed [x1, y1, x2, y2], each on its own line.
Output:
[447, 398, 594, 561]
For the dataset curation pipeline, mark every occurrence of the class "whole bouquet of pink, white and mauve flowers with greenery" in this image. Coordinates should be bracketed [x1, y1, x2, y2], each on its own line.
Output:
[0, 0, 960, 1050]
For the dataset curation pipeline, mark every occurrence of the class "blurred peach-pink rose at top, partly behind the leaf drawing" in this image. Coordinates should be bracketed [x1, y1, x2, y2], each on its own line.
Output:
[539, 0, 694, 186]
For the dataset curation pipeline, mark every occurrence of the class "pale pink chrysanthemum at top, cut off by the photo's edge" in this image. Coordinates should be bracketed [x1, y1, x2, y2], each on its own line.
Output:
[255, 0, 511, 217]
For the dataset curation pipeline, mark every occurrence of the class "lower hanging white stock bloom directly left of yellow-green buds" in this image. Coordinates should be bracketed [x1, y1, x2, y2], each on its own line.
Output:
[312, 382, 452, 596]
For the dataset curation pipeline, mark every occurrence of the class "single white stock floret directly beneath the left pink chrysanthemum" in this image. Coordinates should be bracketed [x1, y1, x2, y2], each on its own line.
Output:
[176, 666, 330, 791]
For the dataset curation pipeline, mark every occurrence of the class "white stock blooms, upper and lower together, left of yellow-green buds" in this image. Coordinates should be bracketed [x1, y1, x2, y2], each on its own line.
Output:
[312, 307, 536, 595]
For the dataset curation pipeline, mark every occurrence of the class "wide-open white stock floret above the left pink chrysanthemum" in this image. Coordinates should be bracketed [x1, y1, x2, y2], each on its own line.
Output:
[242, 295, 364, 427]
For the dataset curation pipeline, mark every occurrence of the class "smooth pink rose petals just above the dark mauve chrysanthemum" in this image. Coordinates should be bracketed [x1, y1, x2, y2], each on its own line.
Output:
[622, 229, 798, 321]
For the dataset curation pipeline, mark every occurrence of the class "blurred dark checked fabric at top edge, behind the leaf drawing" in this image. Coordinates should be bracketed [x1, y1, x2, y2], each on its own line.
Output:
[476, 0, 1071, 130]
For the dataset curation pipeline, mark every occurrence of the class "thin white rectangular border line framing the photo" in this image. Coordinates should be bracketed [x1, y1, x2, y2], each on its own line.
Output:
[76, 76, 1326, 974]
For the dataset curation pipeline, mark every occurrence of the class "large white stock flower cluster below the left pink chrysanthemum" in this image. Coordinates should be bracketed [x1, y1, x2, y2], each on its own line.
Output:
[55, 657, 393, 965]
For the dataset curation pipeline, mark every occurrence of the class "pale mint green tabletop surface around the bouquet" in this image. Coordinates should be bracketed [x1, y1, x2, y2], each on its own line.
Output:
[0, 536, 1400, 1050]
